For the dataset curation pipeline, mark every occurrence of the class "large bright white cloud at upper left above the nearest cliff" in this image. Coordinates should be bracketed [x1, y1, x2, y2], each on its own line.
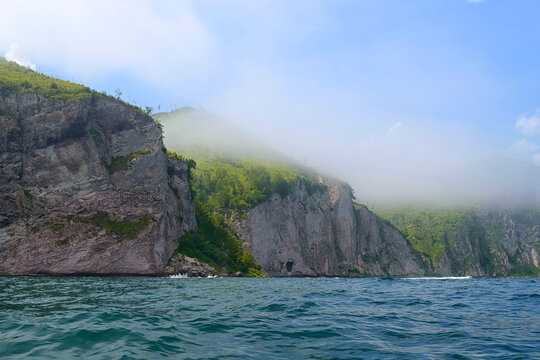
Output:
[0, 0, 216, 86]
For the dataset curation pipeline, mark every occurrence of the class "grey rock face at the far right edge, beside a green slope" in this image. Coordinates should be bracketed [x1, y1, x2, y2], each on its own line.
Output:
[430, 208, 540, 276]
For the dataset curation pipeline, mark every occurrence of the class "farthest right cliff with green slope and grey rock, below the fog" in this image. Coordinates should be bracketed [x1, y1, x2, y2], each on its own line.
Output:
[382, 208, 540, 276]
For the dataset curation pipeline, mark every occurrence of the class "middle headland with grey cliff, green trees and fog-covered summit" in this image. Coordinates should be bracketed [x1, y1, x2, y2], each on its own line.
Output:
[156, 108, 425, 277]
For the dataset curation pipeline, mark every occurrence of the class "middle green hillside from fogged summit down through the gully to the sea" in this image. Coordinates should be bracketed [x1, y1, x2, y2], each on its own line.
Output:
[154, 108, 326, 276]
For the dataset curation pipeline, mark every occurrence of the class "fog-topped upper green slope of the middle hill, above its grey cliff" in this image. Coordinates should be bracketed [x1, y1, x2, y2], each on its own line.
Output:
[154, 108, 326, 213]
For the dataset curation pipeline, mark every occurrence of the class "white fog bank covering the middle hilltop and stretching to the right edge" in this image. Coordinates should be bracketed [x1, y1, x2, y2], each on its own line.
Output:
[156, 109, 540, 207]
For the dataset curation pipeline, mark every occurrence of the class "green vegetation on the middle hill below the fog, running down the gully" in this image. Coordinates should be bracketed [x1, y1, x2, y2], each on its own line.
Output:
[164, 156, 326, 277]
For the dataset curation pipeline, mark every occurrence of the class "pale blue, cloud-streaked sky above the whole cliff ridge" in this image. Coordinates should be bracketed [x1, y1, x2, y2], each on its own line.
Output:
[0, 0, 540, 202]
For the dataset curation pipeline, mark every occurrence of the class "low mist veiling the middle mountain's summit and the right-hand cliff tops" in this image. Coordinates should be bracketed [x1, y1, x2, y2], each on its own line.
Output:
[154, 107, 540, 208]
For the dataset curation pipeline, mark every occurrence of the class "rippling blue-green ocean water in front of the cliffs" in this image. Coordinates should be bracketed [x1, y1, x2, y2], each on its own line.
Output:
[0, 277, 540, 359]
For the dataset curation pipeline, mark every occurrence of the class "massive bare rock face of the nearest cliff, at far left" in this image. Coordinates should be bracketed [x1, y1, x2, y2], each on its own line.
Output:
[0, 94, 196, 275]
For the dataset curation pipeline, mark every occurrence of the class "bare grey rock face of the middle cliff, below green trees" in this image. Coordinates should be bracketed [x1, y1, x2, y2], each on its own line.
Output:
[233, 181, 424, 277]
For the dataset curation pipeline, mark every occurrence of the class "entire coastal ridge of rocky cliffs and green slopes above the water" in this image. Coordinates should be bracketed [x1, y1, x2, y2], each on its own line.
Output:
[0, 59, 540, 277]
